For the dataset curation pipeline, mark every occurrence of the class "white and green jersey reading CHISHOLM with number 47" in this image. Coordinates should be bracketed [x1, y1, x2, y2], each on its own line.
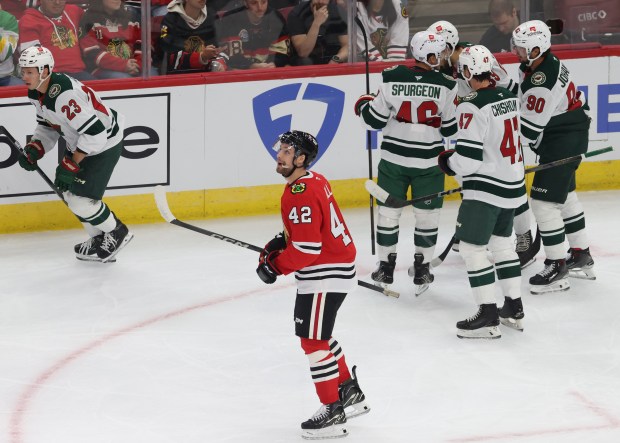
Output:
[448, 88, 527, 209]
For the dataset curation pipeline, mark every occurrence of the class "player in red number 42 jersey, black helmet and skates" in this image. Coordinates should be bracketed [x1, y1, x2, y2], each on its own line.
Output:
[256, 131, 370, 439]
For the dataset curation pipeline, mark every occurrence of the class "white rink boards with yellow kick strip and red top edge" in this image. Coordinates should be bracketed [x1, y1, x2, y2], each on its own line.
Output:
[0, 48, 620, 233]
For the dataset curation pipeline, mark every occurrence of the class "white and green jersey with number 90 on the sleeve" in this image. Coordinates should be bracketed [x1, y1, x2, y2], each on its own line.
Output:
[519, 53, 588, 145]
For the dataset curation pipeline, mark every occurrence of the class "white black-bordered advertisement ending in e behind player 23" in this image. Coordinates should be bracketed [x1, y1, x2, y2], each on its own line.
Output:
[0, 93, 170, 199]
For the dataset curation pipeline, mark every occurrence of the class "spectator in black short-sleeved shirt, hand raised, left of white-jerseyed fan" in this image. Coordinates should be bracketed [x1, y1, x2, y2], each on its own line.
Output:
[287, 0, 349, 65]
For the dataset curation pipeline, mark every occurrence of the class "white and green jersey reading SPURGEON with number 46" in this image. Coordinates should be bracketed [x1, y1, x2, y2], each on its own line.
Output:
[360, 65, 457, 169]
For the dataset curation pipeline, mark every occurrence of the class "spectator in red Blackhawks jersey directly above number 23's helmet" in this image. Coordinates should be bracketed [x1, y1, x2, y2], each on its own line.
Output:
[19, 0, 95, 81]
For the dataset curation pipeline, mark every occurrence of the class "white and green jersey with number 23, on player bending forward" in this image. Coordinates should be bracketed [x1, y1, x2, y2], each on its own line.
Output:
[28, 73, 123, 155]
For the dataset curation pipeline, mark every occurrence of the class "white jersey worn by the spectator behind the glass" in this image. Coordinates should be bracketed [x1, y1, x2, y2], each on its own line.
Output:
[357, 0, 409, 61]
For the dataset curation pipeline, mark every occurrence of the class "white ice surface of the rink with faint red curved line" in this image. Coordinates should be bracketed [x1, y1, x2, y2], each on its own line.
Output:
[0, 192, 620, 443]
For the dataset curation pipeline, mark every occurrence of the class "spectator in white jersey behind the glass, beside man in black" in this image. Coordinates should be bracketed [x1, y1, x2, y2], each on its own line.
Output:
[357, 0, 409, 61]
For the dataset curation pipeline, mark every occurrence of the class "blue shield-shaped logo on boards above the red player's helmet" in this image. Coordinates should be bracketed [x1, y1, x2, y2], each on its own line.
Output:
[252, 83, 344, 166]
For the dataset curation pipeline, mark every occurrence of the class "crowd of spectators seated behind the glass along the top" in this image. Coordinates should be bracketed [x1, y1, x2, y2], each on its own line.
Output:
[0, 0, 620, 86]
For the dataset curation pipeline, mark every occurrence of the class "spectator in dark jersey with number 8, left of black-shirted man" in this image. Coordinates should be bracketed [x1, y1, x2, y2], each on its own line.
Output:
[215, 0, 290, 69]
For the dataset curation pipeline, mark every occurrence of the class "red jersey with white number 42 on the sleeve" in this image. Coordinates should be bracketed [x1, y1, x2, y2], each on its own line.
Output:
[273, 172, 357, 294]
